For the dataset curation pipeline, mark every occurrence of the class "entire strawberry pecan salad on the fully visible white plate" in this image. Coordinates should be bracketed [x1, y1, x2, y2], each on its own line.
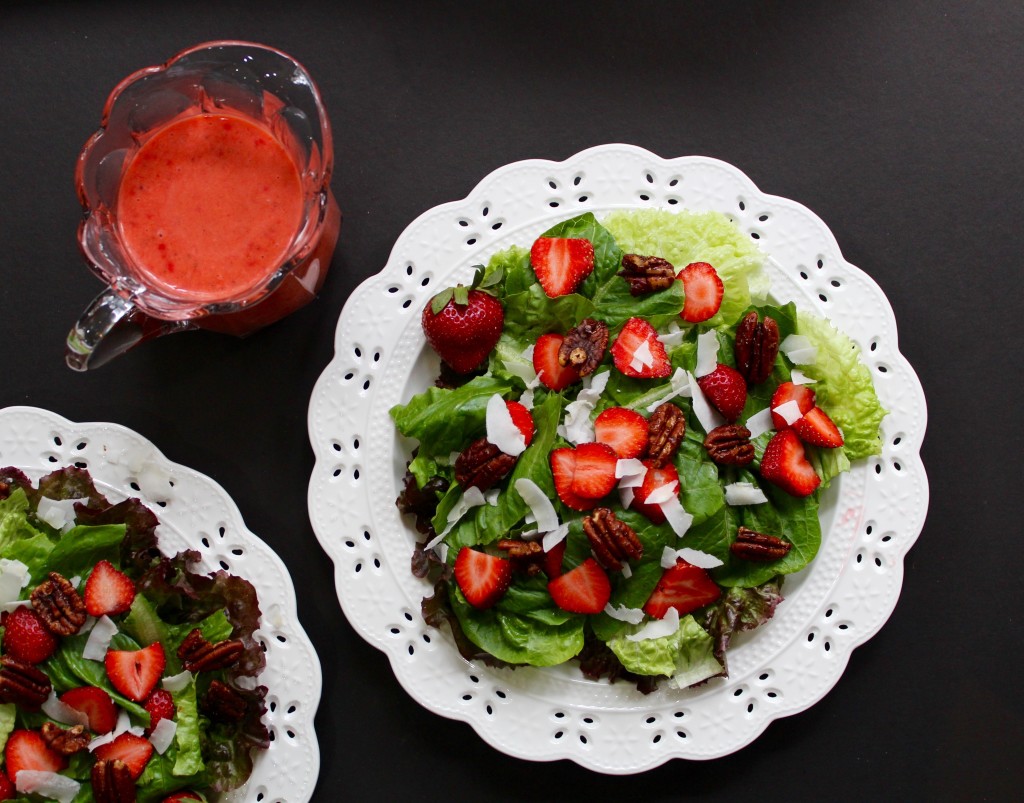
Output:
[390, 210, 886, 691]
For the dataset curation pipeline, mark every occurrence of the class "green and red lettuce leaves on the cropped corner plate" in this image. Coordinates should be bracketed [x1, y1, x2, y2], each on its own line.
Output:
[0, 468, 269, 803]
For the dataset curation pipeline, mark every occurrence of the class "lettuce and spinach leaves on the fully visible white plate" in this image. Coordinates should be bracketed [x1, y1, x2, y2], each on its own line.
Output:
[391, 210, 885, 690]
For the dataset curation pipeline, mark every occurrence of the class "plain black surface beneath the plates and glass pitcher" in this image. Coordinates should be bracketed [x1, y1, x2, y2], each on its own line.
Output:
[0, 0, 1024, 801]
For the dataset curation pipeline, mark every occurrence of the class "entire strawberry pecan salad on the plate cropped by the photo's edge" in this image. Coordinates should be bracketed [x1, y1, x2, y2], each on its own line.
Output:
[0, 467, 269, 803]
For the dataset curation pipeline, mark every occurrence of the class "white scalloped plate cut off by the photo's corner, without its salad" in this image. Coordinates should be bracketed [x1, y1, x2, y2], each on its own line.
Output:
[0, 407, 321, 803]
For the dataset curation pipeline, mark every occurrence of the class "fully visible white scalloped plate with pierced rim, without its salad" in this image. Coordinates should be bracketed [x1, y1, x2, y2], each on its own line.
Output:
[309, 144, 928, 773]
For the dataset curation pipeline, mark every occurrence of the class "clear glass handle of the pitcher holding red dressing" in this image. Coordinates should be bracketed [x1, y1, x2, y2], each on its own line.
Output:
[65, 290, 191, 371]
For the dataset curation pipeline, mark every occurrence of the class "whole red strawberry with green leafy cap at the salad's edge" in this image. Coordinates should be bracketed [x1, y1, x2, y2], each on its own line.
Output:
[422, 269, 505, 374]
